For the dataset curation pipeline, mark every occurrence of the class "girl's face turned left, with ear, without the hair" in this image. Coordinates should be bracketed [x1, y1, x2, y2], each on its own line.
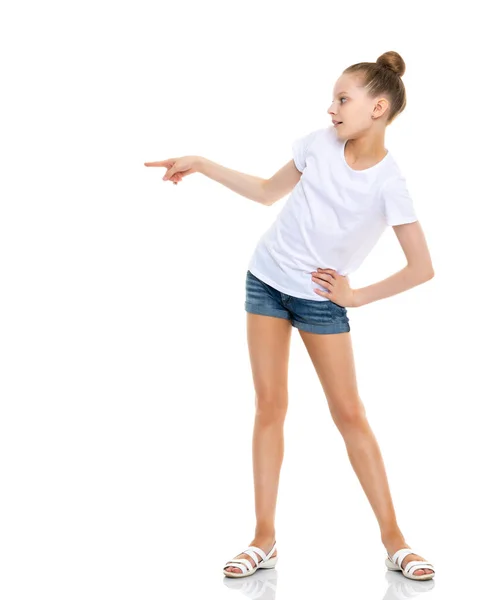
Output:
[328, 74, 389, 139]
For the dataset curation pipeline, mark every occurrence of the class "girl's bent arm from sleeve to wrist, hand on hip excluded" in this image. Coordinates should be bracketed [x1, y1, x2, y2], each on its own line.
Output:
[354, 221, 434, 307]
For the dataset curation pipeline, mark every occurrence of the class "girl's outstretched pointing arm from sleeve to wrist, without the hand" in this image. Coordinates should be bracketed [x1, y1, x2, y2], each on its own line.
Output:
[195, 156, 301, 206]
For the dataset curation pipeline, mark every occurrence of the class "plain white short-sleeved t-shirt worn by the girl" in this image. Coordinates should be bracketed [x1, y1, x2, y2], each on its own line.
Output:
[248, 126, 418, 301]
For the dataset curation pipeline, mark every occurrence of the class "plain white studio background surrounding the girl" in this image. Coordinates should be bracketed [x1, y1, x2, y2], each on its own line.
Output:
[0, 0, 479, 600]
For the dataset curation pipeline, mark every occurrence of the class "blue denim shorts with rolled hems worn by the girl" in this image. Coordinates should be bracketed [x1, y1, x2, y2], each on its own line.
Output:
[244, 270, 350, 333]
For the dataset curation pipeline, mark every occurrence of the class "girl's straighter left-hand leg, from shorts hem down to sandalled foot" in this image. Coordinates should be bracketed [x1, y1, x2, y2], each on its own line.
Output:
[227, 313, 291, 573]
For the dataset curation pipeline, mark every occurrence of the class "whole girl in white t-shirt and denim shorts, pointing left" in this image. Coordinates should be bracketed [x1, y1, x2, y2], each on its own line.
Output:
[145, 51, 435, 579]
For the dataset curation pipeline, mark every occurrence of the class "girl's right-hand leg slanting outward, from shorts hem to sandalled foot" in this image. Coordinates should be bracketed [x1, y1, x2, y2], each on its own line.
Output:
[300, 331, 433, 575]
